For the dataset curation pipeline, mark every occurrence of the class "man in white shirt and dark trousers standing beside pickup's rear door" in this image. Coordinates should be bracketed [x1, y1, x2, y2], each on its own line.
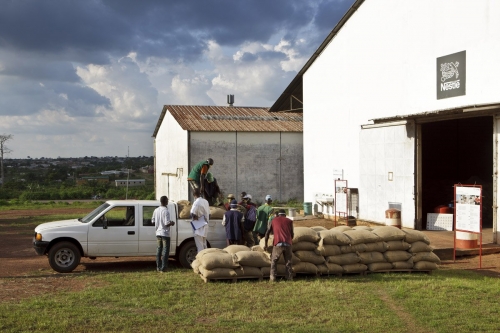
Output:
[151, 196, 175, 273]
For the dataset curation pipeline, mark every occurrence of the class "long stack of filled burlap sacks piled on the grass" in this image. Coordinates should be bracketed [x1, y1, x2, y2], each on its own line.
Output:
[192, 226, 441, 279]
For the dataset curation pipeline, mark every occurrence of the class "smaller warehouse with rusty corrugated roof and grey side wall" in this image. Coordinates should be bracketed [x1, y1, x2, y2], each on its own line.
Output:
[153, 105, 304, 202]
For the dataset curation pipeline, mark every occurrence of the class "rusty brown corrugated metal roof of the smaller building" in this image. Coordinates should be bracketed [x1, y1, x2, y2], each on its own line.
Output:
[153, 105, 303, 137]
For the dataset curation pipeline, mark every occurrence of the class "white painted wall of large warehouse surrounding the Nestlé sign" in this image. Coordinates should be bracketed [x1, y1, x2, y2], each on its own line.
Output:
[303, 0, 500, 222]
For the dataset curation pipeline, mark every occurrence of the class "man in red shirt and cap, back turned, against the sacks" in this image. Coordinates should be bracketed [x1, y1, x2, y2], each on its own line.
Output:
[264, 209, 293, 282]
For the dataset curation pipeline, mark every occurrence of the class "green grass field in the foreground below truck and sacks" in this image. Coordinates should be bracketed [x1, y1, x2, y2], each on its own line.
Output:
[0, 269, 500, 332]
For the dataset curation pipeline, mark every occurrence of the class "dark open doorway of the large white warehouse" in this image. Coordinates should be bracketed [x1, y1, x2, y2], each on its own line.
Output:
[422, 117, 493, 228]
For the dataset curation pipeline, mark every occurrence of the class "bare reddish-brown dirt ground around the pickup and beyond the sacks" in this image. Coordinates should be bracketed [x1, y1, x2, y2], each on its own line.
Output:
[0, 208, 500, 302]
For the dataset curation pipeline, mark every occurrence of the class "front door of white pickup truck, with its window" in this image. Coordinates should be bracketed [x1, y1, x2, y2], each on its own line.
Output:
[88, 205, 139, 257]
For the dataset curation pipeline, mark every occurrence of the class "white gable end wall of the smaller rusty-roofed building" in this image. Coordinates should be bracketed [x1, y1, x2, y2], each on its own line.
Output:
[155, 112, 189, 201]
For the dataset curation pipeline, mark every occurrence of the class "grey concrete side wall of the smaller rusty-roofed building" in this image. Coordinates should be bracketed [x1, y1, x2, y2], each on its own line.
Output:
[190, 132, 303, 202]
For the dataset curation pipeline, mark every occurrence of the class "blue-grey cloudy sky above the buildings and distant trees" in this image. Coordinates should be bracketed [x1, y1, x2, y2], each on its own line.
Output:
[0, 0, 354, 158]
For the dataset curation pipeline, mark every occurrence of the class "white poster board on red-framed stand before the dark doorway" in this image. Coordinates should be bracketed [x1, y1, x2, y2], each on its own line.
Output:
[455, 185, 481, 232]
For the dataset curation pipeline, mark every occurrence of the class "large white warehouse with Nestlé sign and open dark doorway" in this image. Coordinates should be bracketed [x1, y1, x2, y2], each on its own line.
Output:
[271, 0, 500, 242]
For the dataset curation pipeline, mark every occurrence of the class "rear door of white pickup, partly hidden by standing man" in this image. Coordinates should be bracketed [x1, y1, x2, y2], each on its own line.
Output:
[139, 204, 177, 255]
